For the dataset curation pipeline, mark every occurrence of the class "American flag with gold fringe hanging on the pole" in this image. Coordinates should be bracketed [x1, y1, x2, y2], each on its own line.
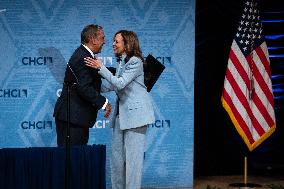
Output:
[221, 1, 276, 151]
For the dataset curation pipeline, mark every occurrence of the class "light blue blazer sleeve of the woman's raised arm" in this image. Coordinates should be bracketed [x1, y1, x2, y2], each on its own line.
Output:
[99, 57, 143, 90]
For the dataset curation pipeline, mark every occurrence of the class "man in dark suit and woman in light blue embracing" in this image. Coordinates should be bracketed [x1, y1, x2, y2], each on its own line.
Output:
[54, 24, 155, 189]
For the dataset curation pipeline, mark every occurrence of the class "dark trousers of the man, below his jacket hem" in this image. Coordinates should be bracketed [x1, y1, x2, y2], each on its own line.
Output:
[55, 118, 89, 147]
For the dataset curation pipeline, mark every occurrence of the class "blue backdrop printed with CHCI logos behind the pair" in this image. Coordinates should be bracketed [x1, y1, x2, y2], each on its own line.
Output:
[0, 0, 195, 187]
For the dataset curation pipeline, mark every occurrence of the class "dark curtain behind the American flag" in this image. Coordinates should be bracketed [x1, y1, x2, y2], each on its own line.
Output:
[194, 0, 284, 177]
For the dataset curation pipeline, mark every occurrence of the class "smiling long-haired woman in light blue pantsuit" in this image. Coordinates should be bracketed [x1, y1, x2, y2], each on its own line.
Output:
[85, 30, 155, 189]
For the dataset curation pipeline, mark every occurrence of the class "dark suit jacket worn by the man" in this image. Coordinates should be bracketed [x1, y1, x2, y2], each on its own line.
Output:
[53, 45, 106, 127]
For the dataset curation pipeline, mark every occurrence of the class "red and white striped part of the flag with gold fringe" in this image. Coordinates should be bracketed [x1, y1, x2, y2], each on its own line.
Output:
[222, 40, 276, 150]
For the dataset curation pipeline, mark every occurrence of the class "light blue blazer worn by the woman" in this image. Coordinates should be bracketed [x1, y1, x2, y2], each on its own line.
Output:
[99, 56, 155, 130]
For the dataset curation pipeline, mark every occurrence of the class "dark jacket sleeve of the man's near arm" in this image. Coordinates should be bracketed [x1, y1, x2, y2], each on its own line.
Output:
[71, 58, 106, 109]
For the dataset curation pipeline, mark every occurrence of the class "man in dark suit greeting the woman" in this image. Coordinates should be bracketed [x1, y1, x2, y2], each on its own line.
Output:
[54, 24, 111, 146]
